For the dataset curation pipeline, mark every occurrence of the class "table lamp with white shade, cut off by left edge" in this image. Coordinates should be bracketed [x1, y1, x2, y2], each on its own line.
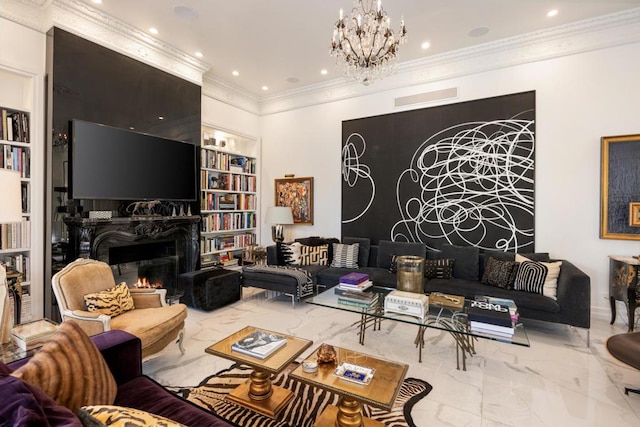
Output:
[0, 169, 22, 344]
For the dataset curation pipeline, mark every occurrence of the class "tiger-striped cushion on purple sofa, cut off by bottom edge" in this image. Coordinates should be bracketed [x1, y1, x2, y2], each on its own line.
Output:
[78, 405, 182, 427]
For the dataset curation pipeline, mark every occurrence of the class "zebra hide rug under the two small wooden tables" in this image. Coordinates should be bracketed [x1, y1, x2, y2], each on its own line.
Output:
[167, 364, 432, 427]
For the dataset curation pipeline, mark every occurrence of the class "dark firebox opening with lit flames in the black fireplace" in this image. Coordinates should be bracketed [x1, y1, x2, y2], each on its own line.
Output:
[109, 240, 179, 288]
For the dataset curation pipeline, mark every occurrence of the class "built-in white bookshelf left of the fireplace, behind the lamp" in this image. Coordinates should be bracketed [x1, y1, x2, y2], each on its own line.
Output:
[0, 106, 31, 323]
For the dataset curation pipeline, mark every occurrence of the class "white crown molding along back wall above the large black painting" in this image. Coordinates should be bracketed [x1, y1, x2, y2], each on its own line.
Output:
[259, 8, 640, 115]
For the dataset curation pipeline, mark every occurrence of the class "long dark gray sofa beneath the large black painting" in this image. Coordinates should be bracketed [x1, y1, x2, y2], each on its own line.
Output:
[244, 237, 591, 338]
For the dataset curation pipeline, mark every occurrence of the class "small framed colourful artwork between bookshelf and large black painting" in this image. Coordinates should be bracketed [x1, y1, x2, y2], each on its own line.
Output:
[275, 177, 313, 225]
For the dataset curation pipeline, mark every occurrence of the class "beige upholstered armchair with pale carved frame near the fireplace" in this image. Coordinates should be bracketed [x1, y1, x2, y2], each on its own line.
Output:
[51, 259, 187, 360]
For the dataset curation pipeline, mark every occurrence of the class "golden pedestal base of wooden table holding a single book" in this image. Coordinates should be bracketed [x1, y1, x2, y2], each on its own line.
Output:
[227, 369, 293, 418]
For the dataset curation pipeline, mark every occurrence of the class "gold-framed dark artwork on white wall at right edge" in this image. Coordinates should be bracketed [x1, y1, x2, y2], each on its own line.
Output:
[600, 134, 640, 240]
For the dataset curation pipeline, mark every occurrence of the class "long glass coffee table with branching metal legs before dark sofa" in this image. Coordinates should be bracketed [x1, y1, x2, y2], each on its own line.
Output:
[305, 286, 530, 371]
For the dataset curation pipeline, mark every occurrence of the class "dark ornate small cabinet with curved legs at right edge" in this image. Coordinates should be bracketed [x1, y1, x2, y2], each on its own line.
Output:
[609, 255, 640, 332]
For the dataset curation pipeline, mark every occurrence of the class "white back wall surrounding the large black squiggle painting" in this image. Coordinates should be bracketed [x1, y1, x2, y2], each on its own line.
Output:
[261, 43, 640, 319]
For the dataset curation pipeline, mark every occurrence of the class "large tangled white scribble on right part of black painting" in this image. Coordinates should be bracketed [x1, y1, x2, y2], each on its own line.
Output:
[391, 112, 534, 250]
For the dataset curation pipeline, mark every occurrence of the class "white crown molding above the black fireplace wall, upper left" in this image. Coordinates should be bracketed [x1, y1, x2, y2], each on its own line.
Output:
[0, 0, 209, 85]
